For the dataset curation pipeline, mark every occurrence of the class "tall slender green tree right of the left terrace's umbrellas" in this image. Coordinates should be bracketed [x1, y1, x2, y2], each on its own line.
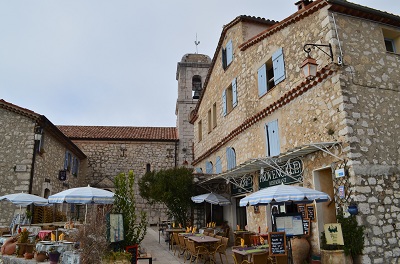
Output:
[113, 171, 147, 247]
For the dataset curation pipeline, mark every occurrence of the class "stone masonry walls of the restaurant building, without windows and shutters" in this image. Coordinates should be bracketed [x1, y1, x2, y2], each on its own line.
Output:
[192, 0, 400, 263]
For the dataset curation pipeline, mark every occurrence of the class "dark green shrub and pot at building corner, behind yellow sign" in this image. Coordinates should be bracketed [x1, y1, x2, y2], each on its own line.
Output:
[321, 212, 365, 264]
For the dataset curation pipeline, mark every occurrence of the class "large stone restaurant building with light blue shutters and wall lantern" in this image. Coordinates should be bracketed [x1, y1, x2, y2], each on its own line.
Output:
[191, 0, 400, 263]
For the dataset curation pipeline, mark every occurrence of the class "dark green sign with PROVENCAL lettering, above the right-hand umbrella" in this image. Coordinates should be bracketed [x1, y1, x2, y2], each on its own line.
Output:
[260, 159, 303, 189]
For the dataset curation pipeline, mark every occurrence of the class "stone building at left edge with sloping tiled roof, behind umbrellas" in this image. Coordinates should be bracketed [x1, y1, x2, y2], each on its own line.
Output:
[0, 100, 86, 226]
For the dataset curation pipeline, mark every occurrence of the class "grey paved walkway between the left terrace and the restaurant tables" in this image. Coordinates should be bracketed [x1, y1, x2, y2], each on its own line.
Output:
[138, 227, 233, 264]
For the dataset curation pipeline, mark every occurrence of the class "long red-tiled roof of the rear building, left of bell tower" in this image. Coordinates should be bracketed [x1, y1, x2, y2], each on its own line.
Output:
[57, 126, 178, 141]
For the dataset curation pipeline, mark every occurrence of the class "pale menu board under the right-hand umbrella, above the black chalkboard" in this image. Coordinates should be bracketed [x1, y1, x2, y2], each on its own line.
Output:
[274, 213, 304, 237]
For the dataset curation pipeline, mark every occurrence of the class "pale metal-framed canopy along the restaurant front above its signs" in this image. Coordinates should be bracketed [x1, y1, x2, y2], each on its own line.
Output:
[199, 142, 343, 192]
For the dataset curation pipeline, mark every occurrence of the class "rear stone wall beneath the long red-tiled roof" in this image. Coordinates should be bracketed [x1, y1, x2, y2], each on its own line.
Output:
[74, 140, 176, 224]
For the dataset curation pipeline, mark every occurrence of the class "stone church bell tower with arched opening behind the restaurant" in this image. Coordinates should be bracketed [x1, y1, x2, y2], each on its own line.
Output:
[175, 54, 211, 167]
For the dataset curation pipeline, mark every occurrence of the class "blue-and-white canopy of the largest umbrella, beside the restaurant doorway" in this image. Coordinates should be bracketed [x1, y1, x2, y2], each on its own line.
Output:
[240, 184, 331, 206]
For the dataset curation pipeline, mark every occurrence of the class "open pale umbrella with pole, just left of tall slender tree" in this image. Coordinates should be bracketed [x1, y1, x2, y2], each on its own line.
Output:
[49, 185, 114, 222]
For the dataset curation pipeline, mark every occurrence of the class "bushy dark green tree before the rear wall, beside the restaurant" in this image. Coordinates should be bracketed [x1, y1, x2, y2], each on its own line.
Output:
[139, 167, 194, 225]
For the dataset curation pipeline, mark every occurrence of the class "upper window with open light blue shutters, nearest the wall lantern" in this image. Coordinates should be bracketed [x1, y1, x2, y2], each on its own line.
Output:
[257, 48, 285, 96]
